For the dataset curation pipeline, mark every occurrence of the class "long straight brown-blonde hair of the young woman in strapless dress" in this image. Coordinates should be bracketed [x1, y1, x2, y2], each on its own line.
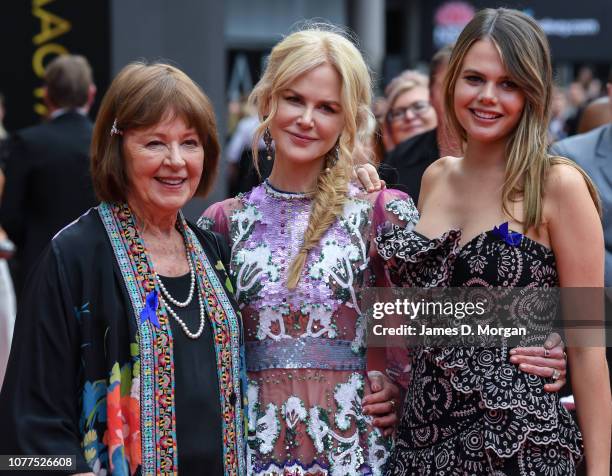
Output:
[444, 8, 601, 232]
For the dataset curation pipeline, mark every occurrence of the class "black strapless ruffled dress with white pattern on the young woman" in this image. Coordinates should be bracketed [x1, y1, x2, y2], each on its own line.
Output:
[377, 226, 582, 476]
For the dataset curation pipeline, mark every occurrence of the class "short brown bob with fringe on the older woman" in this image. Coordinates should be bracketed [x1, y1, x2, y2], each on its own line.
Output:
[91, 62, 220, 202]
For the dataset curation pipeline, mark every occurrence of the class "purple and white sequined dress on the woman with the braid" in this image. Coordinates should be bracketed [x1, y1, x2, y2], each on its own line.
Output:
[200, 182, 417, 476]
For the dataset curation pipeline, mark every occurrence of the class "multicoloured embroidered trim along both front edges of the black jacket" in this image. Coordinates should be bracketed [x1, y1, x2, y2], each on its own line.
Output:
[98, 203, 245, 476]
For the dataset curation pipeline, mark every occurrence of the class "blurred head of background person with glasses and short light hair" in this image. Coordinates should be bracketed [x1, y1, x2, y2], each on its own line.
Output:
[383, 70, 438, 152]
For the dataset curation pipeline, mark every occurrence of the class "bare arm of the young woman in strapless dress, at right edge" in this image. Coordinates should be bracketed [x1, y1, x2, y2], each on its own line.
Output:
[544, 165, 612, 476]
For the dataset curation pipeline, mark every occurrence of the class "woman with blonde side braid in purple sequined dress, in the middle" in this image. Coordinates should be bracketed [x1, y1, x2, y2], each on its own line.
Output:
[200, 26, 416, 475]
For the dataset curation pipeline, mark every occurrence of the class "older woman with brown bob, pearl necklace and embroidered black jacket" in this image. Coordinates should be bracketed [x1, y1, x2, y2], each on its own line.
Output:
[0, 63, 244, 475]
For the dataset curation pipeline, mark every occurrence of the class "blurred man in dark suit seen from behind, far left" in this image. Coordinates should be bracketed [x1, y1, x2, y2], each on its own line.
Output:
[0, 55, 96, 290]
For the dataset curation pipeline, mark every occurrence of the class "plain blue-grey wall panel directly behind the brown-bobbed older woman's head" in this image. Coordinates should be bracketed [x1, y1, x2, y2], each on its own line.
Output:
[109, 0, 227, 218]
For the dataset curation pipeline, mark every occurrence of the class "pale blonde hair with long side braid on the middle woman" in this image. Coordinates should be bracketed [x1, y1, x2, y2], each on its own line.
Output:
[249, 24, 375, 289]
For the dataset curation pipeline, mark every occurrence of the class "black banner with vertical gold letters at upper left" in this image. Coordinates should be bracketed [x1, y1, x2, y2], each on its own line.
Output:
[0, 0, 110, 131]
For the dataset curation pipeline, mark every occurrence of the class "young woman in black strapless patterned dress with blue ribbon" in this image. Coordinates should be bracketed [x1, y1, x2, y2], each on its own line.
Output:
[379, 9, 611, 475]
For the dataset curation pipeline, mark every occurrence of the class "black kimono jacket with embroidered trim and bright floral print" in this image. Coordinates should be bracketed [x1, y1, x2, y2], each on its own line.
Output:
[0, 204, 244, 476]
